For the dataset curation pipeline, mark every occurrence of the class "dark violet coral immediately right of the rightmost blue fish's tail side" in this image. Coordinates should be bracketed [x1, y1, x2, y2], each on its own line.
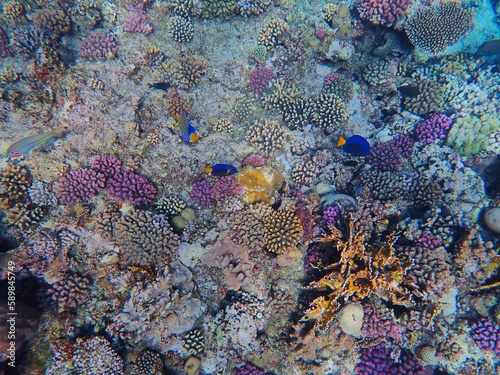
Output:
[368, 134, 414, 172]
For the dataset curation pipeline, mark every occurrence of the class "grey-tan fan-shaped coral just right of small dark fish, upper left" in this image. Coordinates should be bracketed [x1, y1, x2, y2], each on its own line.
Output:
[162, 56, 208, 90]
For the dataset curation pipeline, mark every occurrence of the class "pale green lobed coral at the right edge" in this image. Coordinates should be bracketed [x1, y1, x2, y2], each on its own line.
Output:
[446, 114, 500, 156]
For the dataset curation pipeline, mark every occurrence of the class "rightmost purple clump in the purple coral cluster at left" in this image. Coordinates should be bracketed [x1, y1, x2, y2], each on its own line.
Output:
[107, 172, 156, 205]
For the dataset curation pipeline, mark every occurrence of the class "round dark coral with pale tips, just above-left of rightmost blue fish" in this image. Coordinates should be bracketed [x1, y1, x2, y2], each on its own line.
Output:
[311, 93, 349, 131]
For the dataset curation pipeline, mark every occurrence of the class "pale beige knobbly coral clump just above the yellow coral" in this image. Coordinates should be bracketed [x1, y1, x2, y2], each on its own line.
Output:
[245, 120, 290, 154]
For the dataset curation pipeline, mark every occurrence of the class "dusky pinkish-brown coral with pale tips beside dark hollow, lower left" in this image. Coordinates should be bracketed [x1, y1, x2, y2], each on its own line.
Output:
[49, 273, 92, 313]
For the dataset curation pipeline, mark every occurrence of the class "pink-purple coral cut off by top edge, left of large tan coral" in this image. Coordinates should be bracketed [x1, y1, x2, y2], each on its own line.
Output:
[358, 0, 411, 26]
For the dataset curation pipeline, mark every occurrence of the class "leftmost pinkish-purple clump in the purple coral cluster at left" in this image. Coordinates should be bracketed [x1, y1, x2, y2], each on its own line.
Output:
[58, 168, 106, 204]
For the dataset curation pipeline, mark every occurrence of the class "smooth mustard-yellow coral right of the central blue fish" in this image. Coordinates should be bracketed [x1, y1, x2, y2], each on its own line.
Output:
[236, 166, 283, 204]
